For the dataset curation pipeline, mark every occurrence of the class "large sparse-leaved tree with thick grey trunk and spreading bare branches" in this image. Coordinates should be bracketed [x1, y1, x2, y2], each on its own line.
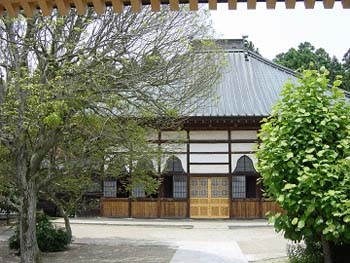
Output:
[0, 8, 220, 262]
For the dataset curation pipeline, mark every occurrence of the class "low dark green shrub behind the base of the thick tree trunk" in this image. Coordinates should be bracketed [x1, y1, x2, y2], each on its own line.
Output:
[9, 213, 71, 252]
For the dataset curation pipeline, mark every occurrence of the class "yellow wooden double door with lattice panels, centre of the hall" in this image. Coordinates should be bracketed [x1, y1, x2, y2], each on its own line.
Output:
[190, 177, 230, 218]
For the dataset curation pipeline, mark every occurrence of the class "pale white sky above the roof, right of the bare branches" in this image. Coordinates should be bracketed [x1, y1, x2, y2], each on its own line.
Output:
[210, 2, 350, 60]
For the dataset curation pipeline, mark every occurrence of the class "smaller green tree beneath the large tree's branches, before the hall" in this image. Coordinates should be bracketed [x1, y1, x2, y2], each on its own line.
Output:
[40, 114, 159, 235]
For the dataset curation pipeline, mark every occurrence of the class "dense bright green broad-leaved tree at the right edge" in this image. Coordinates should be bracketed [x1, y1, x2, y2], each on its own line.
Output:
[257, 69, 350, 262]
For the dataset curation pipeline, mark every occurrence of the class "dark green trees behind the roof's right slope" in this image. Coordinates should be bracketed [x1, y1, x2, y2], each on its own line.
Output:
[273, 42, 350, 90]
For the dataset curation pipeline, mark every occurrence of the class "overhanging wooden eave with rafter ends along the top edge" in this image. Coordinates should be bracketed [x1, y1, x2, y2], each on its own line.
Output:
[0, 0, 350, 17]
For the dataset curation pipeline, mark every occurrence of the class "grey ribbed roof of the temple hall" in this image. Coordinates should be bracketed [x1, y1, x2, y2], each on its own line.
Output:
[191, 50, 296, 117]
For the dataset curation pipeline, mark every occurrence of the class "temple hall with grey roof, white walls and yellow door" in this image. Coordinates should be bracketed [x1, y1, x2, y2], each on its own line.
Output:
[101, 40, 296, 218]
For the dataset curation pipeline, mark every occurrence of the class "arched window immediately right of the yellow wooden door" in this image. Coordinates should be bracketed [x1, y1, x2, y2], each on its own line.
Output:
[232, 155, 260, 198]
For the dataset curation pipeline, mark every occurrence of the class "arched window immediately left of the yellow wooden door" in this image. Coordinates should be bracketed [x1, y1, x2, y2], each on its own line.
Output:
[161, 156, 187, 198]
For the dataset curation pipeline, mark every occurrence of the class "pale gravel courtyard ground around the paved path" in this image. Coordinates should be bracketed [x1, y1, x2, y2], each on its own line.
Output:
[0, 220, 288, 263]
